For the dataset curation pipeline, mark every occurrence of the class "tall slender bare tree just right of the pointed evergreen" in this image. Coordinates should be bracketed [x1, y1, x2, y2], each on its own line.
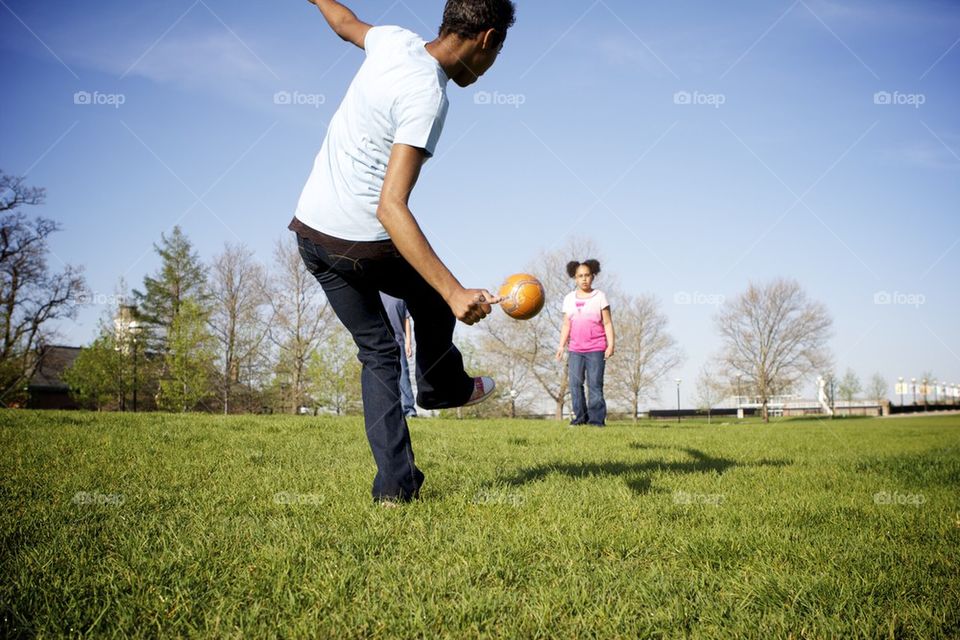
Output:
[210, 243, 270, 414]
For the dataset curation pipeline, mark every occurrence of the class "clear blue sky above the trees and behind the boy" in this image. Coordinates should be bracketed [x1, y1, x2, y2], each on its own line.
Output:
[0, 0, 960, 402]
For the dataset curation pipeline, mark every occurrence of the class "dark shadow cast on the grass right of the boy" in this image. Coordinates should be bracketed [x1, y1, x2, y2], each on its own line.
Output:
[499, 443, 793, 495]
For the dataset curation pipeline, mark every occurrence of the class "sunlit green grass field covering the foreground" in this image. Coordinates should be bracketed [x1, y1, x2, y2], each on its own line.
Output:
[0, 411, 960, 638]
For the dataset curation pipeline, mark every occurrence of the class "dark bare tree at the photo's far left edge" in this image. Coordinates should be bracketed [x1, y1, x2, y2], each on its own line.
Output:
[0, 172, 87, 404]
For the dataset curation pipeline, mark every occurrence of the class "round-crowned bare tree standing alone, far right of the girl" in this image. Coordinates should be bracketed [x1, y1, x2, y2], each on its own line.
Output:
[716, 279, 833, 421]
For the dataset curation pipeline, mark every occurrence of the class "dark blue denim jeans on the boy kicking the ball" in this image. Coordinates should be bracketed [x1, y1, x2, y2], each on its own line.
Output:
[297, 235, 474, 500]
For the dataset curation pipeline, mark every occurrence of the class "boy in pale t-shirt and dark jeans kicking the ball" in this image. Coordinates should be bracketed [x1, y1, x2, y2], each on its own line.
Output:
[289, 0, 515, 504]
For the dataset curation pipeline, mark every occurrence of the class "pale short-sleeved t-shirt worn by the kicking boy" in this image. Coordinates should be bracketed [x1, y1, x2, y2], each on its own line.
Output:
[296, 27, 449, 241]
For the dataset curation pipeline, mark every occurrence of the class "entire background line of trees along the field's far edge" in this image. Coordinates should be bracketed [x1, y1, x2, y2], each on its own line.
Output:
[9, 172, 908, 418]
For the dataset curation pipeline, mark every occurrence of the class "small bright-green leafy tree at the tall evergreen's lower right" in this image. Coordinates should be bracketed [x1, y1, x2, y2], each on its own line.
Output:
[158, 298, 216, 411]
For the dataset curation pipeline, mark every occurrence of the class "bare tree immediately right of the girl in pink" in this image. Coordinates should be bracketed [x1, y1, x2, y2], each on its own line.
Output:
[608, 295, 683, 422]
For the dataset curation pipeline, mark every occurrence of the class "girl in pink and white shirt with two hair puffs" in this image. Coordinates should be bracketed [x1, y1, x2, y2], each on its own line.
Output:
[557, 259, 614, 427]
